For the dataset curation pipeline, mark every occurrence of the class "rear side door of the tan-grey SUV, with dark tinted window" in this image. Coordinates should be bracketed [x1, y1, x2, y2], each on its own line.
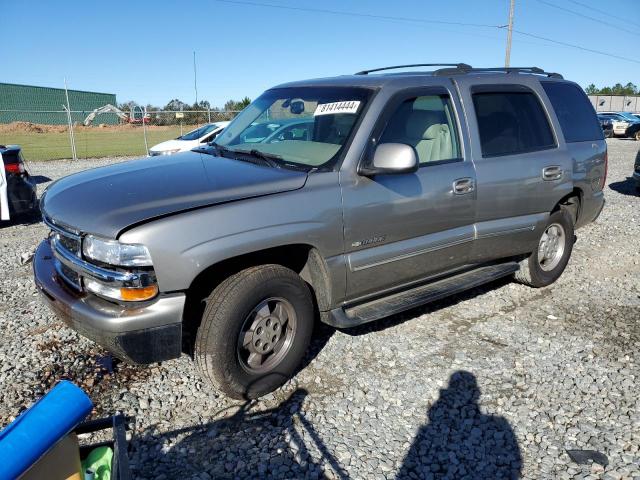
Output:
[455, 74, 572, 262]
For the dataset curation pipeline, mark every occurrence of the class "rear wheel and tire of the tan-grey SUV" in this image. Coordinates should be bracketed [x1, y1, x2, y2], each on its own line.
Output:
[514, 209, 575, 288]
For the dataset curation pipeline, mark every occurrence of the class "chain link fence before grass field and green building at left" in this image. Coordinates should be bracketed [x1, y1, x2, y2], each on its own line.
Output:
[0, 106, 238, 160]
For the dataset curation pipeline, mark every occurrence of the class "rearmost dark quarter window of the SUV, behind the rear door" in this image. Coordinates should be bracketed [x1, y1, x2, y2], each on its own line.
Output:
[542, 82, 604, 143]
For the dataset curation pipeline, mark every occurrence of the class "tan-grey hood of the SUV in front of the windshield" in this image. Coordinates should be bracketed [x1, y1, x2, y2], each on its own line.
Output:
[41, 152, 307, 238]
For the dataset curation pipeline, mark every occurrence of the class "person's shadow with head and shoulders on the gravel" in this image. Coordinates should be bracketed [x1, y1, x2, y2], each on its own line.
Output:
[397, 371, 522, 480]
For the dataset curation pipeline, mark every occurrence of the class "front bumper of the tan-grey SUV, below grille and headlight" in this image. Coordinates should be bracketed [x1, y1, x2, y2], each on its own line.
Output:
[33, 240, 185, 364]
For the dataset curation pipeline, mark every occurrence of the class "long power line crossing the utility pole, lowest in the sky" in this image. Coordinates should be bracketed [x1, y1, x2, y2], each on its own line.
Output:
[214, 0, 640, 64]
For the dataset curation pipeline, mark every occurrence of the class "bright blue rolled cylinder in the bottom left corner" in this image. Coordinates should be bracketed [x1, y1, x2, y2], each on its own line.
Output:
[0, 380, 93, 480]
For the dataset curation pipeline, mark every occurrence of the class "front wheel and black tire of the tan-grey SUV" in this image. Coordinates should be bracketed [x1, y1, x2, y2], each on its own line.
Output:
[194, 265, 314, 399]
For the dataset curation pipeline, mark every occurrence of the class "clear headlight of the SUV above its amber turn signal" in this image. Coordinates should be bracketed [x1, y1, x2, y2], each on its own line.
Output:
[82, 235, 153, 267]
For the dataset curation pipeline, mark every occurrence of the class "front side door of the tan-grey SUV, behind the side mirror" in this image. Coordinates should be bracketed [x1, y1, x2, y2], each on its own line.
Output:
[341, 87, 475, 300]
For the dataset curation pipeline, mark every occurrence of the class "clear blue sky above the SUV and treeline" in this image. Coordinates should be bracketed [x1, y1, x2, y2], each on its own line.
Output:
[0, 0, 640, 106]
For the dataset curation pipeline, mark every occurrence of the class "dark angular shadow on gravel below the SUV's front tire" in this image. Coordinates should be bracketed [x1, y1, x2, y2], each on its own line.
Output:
[133, 389, 349, 480]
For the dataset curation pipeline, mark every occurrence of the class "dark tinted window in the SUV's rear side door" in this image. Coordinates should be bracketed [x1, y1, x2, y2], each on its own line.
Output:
[473, 92, 555, 157]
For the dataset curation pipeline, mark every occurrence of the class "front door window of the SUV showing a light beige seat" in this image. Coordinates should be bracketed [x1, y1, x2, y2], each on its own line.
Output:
[380, 95, 461, 165]
